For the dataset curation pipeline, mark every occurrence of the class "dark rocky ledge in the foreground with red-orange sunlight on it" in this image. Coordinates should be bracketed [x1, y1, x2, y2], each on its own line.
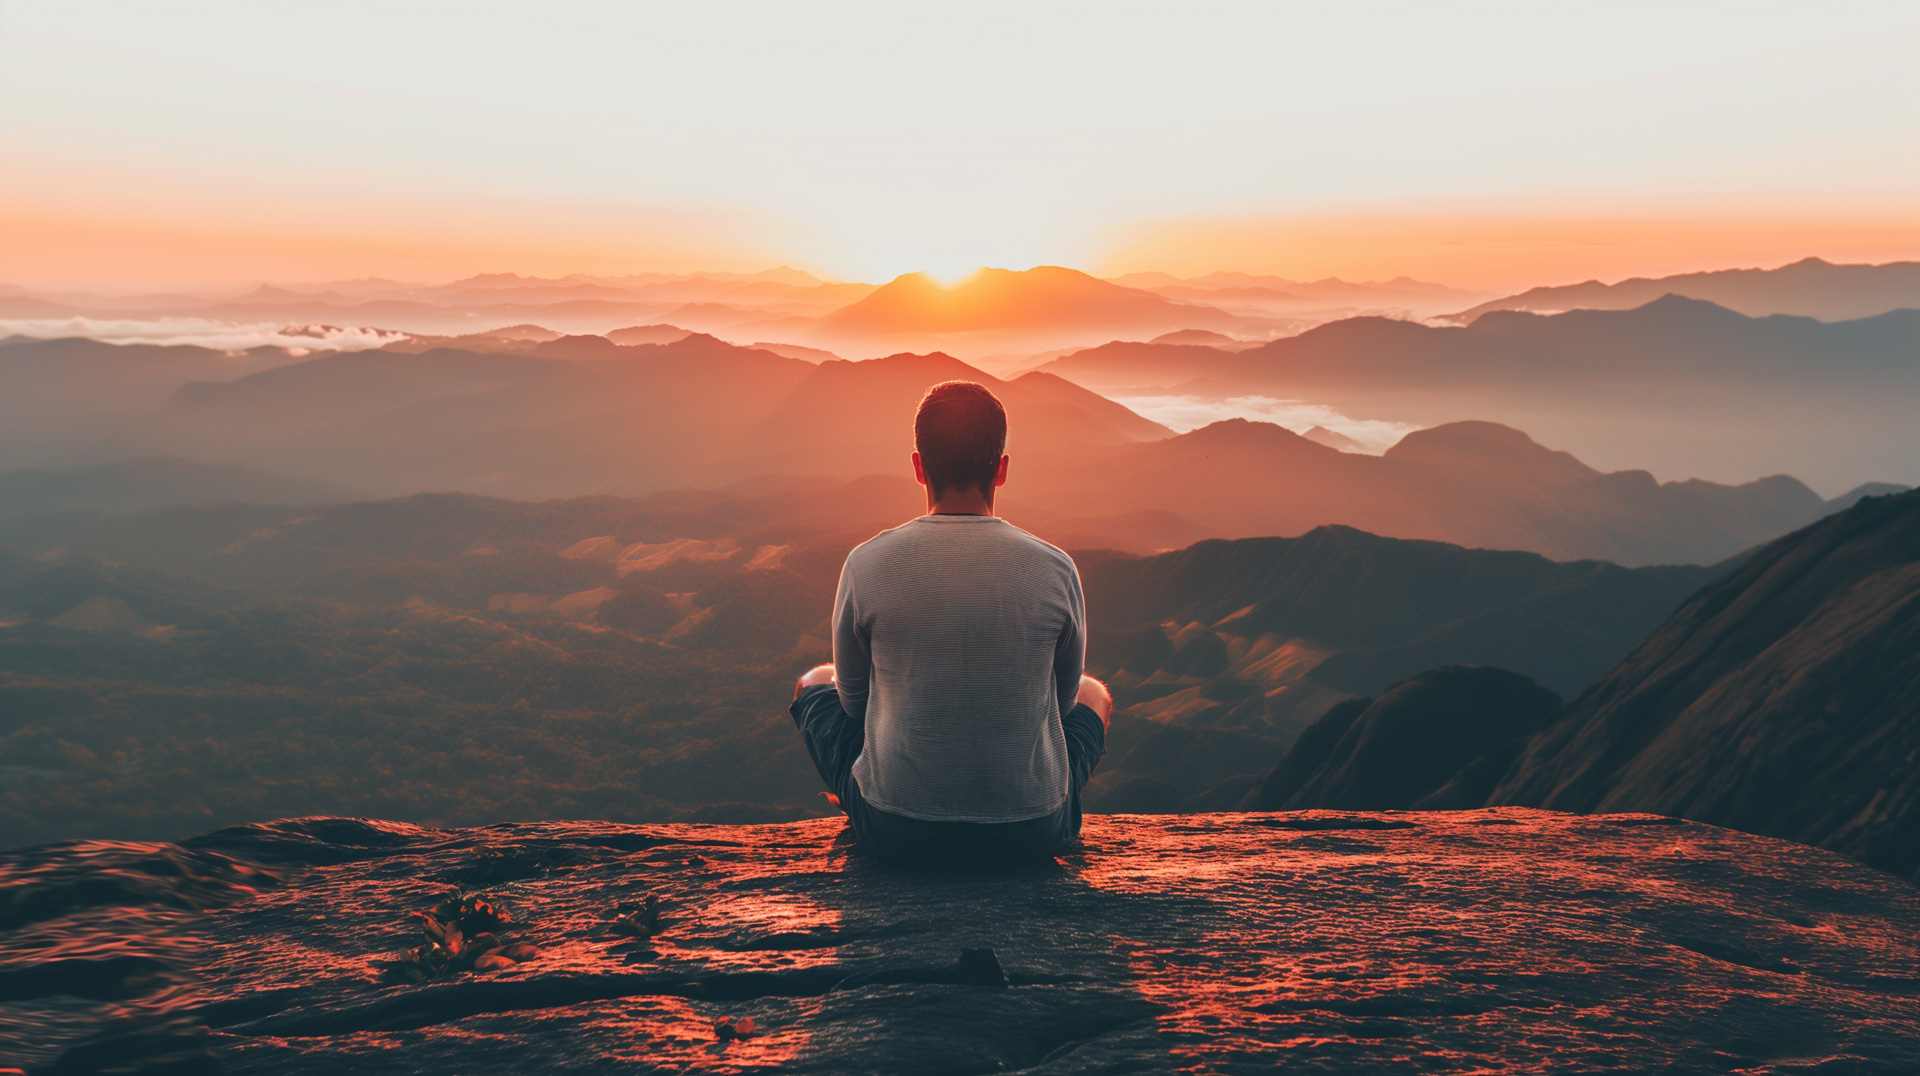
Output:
[0, 809, 1920, 1074]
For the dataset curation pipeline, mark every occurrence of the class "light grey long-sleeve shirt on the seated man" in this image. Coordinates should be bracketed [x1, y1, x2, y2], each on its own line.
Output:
[833, 515, 1087, 822]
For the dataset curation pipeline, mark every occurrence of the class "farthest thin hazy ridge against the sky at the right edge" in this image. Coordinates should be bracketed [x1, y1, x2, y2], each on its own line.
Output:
[1448, 257, 1920, 323]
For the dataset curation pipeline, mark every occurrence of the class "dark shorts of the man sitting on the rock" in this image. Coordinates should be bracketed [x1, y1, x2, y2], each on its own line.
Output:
[791, 684, 1106, 867]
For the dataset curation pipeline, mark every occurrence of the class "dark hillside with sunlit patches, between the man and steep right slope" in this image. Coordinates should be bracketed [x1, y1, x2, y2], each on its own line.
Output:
[1075, 526, 1716, 813]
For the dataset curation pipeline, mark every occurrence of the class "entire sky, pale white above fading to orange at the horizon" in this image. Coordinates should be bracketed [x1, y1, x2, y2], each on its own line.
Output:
[0, 0, 1920, 288]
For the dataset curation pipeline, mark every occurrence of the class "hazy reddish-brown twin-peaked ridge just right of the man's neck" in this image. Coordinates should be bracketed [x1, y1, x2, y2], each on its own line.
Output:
[1008, 416, 1826, 565]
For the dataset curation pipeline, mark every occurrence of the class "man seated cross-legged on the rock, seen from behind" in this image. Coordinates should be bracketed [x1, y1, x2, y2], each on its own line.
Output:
[793, 380, 1114, 867]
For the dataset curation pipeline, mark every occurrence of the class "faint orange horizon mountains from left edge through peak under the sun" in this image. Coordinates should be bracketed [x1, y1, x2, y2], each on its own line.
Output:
[0, 265, 1274, 355]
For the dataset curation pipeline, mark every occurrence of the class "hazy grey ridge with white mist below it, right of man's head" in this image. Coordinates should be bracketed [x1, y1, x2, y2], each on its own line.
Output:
[1037, 296, 1920, 490]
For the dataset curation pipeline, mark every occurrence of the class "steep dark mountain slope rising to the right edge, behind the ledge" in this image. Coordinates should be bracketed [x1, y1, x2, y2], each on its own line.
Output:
[1490, 494, 1920, 876]
